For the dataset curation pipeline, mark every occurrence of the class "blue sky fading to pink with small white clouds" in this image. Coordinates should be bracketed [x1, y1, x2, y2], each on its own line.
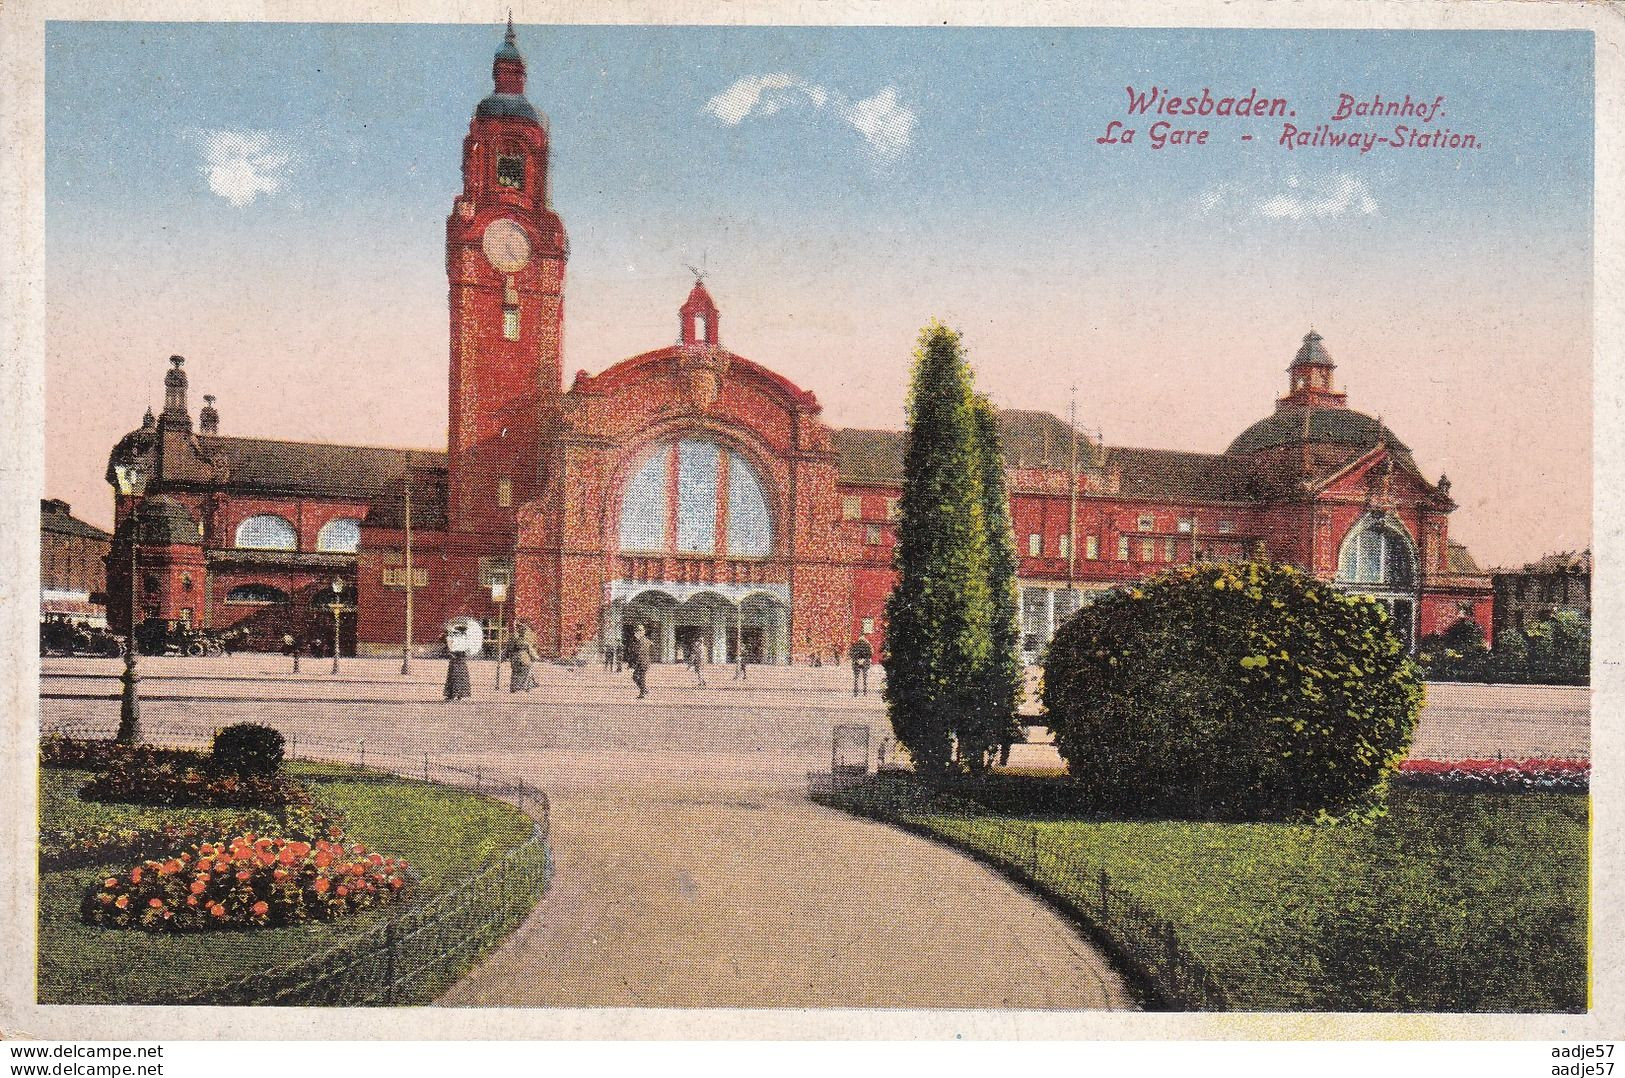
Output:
[46, 21, 1593, 566]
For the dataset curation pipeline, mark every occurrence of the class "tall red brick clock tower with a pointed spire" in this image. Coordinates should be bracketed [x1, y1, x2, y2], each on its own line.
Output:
[445, 16, 569, 554]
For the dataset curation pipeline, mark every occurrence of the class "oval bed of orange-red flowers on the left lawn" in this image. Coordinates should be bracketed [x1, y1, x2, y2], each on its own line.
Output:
[80, 826, 408, 932]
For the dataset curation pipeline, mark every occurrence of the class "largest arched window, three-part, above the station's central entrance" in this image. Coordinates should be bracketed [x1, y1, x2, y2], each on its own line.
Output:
[621, 439, 774, 558]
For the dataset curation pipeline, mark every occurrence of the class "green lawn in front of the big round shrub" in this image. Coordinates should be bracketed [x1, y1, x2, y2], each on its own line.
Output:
[830, 780, 1589, 1011]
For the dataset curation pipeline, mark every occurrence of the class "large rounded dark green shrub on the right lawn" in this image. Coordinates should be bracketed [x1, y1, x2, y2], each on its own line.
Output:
[1043, 563, 1422, 819]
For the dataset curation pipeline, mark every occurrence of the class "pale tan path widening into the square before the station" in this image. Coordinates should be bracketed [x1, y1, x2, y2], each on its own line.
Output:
[41, 657, 1133, 1010]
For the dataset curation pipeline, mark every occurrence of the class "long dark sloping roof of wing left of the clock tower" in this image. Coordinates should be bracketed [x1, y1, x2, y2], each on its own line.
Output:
[198, 436, 445, 501]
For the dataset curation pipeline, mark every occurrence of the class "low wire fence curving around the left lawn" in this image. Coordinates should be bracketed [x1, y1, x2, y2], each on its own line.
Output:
[41, 724, 553, 1006]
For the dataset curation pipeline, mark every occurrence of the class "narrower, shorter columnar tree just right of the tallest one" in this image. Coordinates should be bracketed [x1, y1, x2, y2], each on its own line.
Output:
[959, 393, 1022, 771]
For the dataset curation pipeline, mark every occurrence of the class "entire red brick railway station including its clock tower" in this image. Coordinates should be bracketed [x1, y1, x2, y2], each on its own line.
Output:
[107, 29, 1490, 662]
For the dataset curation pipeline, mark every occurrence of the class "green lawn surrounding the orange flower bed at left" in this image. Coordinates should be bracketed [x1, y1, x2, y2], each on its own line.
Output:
[39, 764, 540, 1003]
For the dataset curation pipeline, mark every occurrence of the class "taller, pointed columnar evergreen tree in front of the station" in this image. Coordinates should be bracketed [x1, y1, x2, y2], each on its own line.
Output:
[886, 322, 993, 774]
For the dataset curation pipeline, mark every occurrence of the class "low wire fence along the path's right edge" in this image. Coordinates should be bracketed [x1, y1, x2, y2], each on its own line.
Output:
[808, 776, 1230, 1011]
